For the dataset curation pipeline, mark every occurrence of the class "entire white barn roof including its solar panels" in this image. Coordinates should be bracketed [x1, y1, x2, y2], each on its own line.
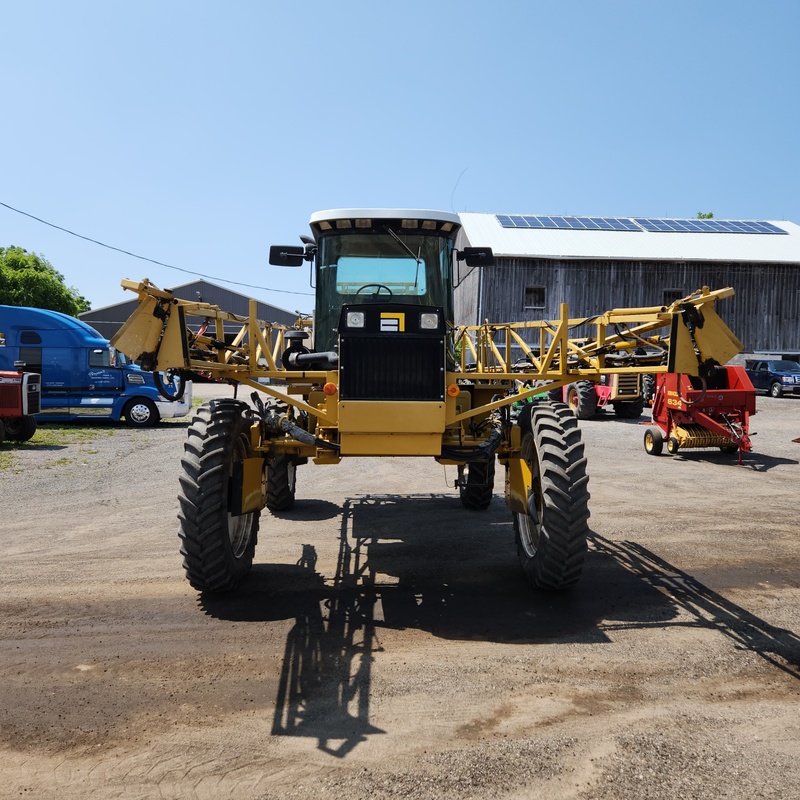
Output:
[459, 212, 800, 264]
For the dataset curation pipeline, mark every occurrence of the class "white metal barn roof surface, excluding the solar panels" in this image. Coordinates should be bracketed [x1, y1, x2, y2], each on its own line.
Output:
[459, 212, 800, 264]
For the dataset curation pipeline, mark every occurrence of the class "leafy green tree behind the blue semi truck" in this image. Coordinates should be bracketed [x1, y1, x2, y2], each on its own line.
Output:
[0, 245, 91, 317]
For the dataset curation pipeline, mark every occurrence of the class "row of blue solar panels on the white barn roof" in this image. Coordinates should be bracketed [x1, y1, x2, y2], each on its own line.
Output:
[496, 214, 788, 234]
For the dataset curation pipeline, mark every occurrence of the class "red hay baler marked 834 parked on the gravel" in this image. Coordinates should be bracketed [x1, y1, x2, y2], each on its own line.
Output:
[644, 367, 756, 462]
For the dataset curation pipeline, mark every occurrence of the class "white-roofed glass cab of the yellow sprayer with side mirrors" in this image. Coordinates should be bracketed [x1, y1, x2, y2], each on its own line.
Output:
[270, 209, 492, 352]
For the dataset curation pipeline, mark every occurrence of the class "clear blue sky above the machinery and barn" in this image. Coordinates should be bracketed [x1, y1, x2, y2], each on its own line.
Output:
[0, 0, 800, 311]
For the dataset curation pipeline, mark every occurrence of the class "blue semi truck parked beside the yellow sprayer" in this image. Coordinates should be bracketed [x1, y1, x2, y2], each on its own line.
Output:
[0, 306, 192, 428]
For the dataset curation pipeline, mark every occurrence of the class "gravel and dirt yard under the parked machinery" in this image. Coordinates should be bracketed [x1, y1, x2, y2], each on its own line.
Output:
[0, 387, 800, 800]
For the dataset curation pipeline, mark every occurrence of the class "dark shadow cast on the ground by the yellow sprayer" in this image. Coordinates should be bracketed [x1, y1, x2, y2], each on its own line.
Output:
[200, 494, 800, 758]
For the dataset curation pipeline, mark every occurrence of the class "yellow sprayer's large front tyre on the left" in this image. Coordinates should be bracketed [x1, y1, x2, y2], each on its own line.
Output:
[178, 399, 260, 592]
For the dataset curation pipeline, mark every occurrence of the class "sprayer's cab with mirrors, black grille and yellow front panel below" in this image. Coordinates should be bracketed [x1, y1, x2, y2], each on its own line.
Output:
[270, 209, 492, 456]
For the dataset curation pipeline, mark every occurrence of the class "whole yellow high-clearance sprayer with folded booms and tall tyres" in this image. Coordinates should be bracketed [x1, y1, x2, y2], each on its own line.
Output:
[112, 209, 742, 591]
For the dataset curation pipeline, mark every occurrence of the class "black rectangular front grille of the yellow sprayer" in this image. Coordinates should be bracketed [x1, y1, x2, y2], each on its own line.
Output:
[339, 333, 445, 400]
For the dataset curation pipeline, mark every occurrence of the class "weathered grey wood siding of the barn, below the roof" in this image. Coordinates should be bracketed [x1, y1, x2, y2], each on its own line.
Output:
[456, 256, 800, 352]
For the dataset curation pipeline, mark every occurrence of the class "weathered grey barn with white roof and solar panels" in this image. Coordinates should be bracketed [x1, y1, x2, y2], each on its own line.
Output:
[455, 213, 800, 352]
